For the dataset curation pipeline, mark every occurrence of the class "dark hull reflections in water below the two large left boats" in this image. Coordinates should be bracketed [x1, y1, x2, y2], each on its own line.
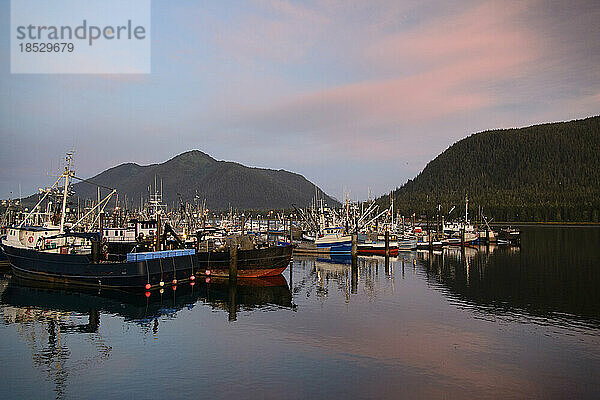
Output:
[2, 275, 293, 329]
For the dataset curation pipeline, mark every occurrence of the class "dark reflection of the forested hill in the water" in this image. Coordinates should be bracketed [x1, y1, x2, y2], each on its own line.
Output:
[417, 229, 600, 329]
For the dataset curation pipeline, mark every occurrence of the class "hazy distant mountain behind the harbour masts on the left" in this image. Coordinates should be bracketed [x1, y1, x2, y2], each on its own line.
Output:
[73, 150, 338, 210]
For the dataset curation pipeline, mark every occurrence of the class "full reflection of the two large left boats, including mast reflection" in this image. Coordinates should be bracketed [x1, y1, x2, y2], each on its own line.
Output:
[0, 276, 294, 399]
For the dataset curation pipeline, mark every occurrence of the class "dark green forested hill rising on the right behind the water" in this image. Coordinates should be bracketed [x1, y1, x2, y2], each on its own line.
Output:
[380, 116, 600, 222]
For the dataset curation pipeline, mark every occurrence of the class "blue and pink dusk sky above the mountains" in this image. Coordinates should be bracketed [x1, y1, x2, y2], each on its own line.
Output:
[0, 0, 600, 199]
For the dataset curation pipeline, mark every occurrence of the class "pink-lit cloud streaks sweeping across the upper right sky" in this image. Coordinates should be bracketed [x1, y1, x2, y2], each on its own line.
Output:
[223, 2, 538, 147]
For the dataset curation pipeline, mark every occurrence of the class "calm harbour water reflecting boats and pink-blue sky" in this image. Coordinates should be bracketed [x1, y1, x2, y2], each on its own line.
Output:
[0, 228, 600, 399]
